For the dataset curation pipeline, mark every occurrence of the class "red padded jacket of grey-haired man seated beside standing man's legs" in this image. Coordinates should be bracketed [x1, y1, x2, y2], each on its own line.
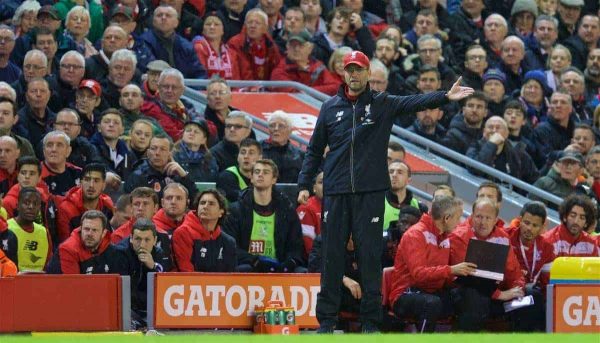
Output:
[388, 214, 453, 304]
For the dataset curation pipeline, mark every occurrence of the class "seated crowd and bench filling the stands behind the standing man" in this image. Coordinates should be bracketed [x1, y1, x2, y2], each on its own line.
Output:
[0, 0, 600, 332]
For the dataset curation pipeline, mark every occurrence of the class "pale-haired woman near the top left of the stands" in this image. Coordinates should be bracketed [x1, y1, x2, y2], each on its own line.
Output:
[59, 6, 98, 58]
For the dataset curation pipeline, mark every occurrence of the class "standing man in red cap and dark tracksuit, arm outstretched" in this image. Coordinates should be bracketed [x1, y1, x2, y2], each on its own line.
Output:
[298, 51, 473, 333]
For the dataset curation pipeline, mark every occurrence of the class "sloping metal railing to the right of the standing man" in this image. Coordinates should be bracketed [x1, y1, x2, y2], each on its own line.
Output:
[392, 125, 562, 205]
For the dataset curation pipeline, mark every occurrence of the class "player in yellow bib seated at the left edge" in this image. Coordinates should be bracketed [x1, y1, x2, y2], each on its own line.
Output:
[7, 187, 52, 272]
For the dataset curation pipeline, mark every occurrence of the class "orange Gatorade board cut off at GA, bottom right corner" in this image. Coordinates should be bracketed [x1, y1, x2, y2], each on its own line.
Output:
[554, 284, 600, 333]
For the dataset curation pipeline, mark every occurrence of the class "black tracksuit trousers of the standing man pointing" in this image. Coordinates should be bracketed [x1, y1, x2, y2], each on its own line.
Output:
[317, 191, 385, 326]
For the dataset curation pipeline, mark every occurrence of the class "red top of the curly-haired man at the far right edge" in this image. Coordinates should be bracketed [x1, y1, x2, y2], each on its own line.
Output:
[542, 224, 598, 257]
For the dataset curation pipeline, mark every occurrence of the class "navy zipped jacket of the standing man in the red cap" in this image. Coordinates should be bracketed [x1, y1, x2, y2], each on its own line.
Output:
[298, 86, 447, 195]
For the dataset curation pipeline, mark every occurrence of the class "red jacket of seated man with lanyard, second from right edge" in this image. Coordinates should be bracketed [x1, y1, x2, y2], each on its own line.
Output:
[506, 226, 555, 289]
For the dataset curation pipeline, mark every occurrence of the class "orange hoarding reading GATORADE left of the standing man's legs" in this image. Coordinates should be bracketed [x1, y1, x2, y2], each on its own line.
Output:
[154, 273, 320, 329]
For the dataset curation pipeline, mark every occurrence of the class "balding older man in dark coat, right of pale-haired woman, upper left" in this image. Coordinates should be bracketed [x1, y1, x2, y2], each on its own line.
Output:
[85, 25, 129, 80]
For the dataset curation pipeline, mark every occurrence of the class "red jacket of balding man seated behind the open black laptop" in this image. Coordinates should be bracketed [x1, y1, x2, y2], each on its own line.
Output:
[450, 222, 525, 299]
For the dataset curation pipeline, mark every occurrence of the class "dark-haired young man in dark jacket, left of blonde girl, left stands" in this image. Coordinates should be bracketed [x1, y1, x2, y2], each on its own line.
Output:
[90, 108, 136, 180]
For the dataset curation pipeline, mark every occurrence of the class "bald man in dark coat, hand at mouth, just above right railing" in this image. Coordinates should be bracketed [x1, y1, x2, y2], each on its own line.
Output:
[467, 116, 539, 184]
